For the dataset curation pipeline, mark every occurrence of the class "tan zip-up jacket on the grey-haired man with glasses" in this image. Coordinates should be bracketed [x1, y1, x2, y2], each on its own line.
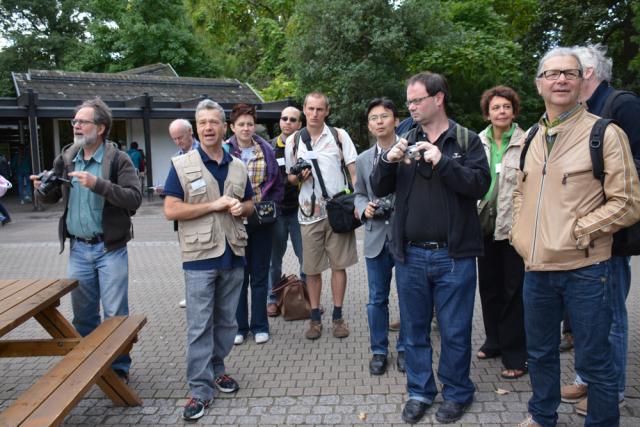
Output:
[511, 108, 640, 271]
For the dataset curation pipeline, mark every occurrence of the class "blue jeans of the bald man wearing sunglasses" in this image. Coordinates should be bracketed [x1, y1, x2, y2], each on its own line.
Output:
[269, 212, 307, 303]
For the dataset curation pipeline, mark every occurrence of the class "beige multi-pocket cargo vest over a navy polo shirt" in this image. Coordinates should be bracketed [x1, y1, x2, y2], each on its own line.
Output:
[171, 150, 247, 262]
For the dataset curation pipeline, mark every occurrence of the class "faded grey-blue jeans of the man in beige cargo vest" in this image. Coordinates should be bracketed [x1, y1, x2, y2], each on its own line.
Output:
[184, 267, 244, 400]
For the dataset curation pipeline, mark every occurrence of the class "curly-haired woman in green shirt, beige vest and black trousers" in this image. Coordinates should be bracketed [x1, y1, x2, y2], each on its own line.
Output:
[477, 86, 527, 379]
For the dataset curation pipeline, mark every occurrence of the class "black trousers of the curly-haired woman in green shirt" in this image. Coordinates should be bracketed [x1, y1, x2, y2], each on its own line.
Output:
[478, 237, 527, 369]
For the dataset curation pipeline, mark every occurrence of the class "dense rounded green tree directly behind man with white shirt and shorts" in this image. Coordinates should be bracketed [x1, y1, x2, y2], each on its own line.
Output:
[287, 0, 407, 147]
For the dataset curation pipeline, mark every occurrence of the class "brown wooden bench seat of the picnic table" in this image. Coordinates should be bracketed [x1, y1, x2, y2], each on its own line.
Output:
[0, 315, 147, 427]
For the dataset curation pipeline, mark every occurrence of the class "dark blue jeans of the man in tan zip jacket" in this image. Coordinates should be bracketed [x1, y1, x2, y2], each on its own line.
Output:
[523, 261, 620, 427]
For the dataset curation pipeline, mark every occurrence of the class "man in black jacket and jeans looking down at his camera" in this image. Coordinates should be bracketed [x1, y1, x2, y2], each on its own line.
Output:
[371, 72, 491, 423]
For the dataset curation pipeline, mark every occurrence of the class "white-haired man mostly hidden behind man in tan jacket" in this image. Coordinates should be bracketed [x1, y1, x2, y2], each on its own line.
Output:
[561, 44, 640, 415]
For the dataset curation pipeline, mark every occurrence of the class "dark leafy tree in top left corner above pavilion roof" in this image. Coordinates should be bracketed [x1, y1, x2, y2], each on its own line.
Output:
[0, 0, 87, 96]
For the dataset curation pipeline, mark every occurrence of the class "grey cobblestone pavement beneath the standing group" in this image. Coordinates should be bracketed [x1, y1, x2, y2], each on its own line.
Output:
[0, 199, 640, 426]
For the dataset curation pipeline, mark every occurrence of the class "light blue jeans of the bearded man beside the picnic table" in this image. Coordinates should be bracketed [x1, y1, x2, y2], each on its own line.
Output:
[68, 240, 131, 372]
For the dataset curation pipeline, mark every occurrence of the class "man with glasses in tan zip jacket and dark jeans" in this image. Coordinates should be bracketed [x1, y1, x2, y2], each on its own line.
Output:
[511, 48, 640, 426]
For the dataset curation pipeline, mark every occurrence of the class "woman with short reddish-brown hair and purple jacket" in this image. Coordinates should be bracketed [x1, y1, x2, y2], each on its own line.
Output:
[226, 104, 284, 345]
